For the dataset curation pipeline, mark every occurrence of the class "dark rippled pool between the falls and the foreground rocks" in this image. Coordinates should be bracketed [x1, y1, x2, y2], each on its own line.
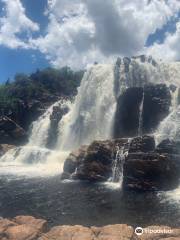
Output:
[0, 175, 180, 226]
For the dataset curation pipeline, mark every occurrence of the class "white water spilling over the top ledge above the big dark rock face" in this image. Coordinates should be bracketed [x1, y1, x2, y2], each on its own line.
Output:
[116, 57, 180, 91]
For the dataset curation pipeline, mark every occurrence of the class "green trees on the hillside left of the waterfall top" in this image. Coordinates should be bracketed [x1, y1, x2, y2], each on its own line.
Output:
[0, 67, 84, 116]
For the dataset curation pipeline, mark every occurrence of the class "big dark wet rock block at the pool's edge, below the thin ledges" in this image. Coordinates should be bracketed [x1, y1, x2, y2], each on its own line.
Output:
[123, 152, 180, 191]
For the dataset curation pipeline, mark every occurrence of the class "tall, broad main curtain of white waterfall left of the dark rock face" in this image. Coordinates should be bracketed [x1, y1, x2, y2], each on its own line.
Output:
[57, 65, 116, 150]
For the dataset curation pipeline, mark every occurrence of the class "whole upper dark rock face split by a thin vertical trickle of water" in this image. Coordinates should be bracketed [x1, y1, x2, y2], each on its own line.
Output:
[114, 84, 171, 138]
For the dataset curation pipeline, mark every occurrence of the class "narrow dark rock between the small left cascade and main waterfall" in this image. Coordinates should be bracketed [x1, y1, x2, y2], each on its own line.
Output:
[47, 104, 69, 148]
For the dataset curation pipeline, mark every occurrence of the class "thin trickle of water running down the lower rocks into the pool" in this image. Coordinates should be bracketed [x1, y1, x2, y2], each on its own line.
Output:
[111, 146, 125, 185]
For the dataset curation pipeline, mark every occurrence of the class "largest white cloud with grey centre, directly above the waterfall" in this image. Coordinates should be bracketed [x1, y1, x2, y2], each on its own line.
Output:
[32, 0, 180, 67]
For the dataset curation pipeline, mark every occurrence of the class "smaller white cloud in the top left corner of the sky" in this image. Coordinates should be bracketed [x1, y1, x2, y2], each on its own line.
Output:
[0, 0, 39, 48]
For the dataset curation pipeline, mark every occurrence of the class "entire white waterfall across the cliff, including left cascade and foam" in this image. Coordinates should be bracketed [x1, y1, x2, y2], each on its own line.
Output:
[0, 55, 180, 178]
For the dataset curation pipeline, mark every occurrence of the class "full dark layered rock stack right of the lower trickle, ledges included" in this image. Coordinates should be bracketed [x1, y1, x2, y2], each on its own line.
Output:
[123, 137, 180, 191]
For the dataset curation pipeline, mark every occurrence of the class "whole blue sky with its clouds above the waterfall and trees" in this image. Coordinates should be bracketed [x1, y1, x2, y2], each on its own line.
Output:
[0, 0, 180, 82]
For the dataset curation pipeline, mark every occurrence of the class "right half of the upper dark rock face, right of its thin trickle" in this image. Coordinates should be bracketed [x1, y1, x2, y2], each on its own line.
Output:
[143, 84, 171, 134]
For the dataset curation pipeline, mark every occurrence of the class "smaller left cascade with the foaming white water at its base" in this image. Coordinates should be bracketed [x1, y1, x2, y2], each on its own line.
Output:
[0, 101, 68, 176]
